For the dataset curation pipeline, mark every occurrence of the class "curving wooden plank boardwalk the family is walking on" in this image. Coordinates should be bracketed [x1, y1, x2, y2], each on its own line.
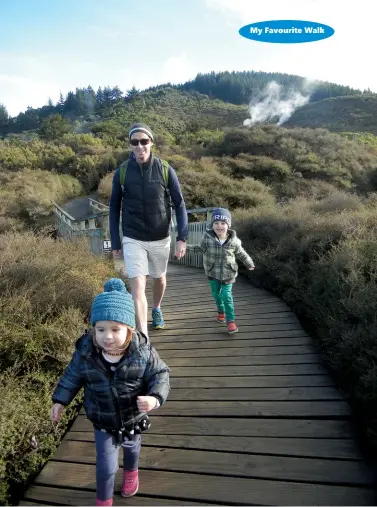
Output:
[22, 266, 376, 505]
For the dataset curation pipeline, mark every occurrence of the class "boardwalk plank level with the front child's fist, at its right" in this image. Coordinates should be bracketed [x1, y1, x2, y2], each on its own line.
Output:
[159, 401, 351, 416]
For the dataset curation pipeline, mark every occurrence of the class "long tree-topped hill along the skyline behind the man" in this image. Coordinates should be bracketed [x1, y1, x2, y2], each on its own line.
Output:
[0, 71, 372, 136]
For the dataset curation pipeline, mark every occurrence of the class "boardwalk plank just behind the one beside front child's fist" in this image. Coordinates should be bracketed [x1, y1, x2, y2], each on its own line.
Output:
[163, 387, 344, 402]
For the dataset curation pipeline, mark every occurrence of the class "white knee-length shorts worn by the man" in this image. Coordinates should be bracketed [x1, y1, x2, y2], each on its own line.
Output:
[122, 236, 171, 278]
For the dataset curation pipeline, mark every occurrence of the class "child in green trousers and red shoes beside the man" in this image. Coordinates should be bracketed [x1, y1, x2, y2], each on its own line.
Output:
[187, 208, 255, 334]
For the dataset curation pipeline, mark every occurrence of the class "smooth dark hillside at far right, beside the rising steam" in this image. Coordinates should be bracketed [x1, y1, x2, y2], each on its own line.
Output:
[285, 94, 377, 134]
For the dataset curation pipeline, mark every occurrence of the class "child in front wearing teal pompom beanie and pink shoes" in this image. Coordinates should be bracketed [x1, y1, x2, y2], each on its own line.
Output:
[51, 278, 169, 505]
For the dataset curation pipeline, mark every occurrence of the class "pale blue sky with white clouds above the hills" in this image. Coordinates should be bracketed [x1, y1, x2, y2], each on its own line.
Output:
[0, 0, 377, 116]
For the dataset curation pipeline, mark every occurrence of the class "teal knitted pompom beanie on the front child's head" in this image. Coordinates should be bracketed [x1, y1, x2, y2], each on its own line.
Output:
[90, 278, 136, 327]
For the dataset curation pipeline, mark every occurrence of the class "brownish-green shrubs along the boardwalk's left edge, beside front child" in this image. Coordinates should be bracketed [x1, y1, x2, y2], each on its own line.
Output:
[0, 232, 116, 503]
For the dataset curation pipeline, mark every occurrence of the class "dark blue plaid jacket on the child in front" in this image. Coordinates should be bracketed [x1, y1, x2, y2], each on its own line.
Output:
[52, 332, 170, 430]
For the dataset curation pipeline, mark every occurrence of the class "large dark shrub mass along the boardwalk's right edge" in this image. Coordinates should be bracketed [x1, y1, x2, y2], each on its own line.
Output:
[235, 204, 377, 452]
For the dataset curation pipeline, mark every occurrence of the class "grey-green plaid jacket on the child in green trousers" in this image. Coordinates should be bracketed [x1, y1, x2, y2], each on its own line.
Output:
[187, 229, 254, 283]
